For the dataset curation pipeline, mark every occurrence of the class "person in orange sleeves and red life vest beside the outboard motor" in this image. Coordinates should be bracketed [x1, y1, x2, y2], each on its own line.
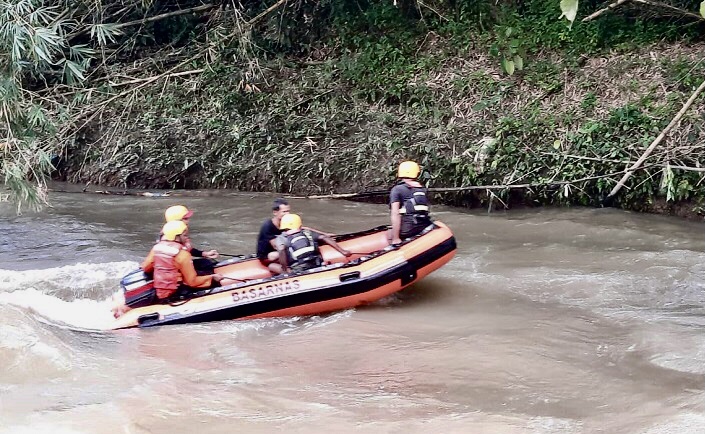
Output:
[142, 220, 223, 301]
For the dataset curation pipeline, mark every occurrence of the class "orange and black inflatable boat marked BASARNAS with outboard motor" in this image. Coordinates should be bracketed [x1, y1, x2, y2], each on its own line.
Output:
[110, 222, 456, 329]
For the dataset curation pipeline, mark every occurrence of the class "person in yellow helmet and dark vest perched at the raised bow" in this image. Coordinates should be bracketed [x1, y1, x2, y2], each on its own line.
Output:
[389, 161, 431, 244]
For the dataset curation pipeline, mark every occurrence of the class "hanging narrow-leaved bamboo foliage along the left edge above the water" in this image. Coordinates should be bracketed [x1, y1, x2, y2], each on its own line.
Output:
[0, 0, 93, 208]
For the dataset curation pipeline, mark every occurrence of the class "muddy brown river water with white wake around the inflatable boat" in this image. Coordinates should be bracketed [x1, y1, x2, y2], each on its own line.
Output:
[0, 193, 705, 434]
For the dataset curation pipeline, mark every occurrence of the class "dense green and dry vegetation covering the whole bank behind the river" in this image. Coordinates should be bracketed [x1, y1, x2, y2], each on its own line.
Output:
[0, 0, 705, 217]
